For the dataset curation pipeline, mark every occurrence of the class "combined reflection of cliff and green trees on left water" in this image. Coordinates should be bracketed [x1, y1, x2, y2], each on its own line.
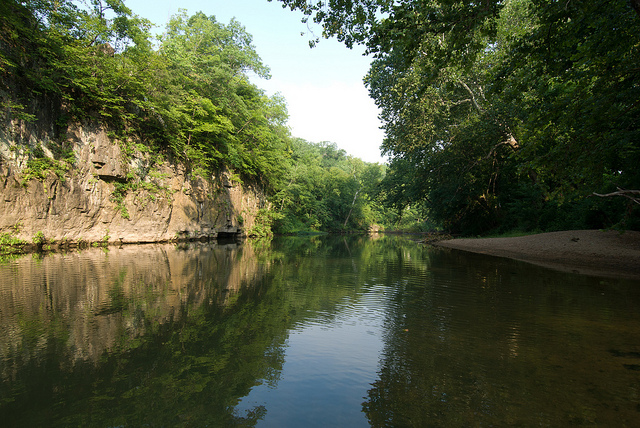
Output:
[0, 245, 285, 426]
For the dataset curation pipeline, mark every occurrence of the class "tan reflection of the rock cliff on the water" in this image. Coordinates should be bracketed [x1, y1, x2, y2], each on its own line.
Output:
[0, 244, 264, 372]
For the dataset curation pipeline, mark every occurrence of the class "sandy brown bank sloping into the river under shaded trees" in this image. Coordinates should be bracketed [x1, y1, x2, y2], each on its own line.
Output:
[433, 230, 640, 280]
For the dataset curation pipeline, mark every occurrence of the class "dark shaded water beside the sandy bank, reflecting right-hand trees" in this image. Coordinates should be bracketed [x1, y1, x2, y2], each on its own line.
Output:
[363, 249, 640, 427]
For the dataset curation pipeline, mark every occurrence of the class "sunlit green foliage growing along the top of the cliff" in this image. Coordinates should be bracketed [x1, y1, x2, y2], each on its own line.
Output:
[0, 0, 289, 189]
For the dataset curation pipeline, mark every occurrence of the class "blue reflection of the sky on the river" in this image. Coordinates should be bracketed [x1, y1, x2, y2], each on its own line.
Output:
[238, 284, 387, 427]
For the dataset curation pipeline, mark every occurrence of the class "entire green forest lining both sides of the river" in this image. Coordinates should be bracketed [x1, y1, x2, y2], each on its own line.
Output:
[0, 0, 640, 235]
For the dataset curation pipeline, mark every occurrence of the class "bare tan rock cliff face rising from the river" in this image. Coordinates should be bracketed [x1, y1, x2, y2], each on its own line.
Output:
[0, 120, 267, 243]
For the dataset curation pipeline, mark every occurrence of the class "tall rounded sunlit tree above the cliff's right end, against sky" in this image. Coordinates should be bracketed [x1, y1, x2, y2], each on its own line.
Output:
[152, 11, 288, 182]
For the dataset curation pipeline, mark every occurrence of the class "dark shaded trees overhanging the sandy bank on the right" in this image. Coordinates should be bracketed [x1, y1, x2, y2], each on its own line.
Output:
[280, 0, 640, 234]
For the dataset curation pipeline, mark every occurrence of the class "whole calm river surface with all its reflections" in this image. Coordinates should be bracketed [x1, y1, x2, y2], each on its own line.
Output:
[0, 236, 640, 427]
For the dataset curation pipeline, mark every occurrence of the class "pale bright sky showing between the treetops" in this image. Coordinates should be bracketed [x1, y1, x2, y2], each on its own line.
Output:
[125, 0, 385, 163]
